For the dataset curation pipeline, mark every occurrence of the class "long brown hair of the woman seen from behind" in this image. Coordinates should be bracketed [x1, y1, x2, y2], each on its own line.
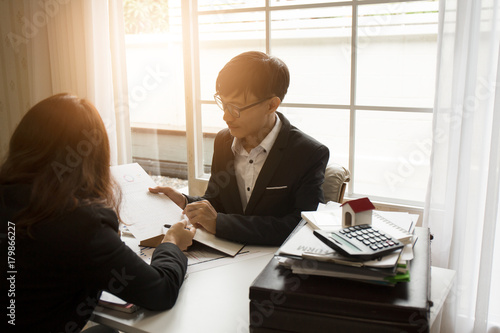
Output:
[0, 94, 120, 234]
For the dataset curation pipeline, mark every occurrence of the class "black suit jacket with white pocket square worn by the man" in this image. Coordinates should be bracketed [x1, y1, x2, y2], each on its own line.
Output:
[187, 112, 329, 245]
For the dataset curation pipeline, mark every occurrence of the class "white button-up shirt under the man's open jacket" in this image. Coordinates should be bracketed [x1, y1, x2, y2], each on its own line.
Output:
[231, 116, 281, 211]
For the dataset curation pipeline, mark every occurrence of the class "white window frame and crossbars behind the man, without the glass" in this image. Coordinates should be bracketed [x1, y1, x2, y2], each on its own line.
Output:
[182, 0, 433, 207]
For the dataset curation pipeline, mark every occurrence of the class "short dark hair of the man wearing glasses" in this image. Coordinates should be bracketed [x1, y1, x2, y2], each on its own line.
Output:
[215, 51, 290, 101]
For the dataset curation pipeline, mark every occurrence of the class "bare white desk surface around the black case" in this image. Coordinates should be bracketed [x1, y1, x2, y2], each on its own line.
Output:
[93, 253, 455, 333]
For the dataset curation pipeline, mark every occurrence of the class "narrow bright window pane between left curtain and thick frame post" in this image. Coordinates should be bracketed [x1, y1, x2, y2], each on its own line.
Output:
[123, 0, 186, 127]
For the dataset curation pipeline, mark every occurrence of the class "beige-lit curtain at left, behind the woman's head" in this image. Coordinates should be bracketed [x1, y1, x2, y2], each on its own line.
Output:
[0, 0, 131, 164]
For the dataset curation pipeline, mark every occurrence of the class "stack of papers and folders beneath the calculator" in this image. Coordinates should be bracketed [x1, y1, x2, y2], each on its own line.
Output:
[277, 203, 418, 286]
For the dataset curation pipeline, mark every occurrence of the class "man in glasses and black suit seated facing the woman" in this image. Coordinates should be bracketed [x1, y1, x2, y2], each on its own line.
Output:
[150, 52, 329, 245]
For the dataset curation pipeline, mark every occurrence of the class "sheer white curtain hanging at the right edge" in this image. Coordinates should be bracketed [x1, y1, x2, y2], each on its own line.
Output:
[424, 0, 500, 333]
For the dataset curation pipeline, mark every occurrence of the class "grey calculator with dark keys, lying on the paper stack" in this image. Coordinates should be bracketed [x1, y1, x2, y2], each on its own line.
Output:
[314, 224, 404, 261]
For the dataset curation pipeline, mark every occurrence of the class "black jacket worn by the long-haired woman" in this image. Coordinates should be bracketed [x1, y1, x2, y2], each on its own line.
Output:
[0, 185, 187, 332]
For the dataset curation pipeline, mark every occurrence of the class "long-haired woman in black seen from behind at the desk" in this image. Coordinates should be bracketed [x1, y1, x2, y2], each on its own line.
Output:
[0, 94, 196, 332]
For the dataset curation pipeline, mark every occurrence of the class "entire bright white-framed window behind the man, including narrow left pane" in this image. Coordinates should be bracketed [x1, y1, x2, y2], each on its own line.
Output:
[127, 0, 438, 206]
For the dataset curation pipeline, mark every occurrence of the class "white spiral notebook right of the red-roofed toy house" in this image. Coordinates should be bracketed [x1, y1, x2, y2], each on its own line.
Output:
[372, 210, 415, 244]
